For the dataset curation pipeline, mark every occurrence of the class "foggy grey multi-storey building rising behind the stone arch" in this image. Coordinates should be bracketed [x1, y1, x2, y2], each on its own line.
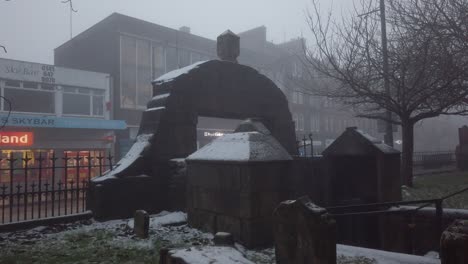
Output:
[54, 13, 376, 156]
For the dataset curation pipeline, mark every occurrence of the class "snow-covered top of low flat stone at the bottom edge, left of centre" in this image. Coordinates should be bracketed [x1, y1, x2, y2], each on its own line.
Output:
[170, 246, 254, 264]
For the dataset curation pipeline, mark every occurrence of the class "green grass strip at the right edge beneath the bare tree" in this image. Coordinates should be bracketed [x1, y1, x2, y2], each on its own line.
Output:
[403, 172, 468, 209]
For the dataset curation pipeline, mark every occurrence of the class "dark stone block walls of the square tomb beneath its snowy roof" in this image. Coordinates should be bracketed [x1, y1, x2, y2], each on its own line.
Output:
[187, 161, 291, 248]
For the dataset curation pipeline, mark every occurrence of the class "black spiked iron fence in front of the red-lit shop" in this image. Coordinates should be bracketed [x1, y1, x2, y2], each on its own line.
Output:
[0, 152, 113, 224]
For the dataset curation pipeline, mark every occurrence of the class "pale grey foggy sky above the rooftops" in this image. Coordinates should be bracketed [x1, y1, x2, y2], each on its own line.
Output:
[0, 0, 353, 64]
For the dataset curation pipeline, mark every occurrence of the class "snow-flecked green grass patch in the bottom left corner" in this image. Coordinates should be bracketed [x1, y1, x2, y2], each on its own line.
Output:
[0, 230, 161, 263]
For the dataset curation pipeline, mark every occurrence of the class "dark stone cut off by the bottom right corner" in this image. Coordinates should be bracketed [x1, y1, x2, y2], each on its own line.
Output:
[440, 220, 468, 264]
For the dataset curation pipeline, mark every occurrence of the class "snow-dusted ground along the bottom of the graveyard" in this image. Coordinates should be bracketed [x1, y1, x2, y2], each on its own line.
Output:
[0, 212, 440, 264]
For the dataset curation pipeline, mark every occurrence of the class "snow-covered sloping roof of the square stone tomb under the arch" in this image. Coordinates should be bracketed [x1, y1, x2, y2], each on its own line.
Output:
[187, 131, 292, 161]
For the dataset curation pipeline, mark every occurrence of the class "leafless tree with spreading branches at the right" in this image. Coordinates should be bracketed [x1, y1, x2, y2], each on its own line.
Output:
[304, 0, 468, 186]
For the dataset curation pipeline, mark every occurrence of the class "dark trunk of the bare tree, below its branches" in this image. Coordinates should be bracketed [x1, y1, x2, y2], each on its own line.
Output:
[401, 120, 414, 187]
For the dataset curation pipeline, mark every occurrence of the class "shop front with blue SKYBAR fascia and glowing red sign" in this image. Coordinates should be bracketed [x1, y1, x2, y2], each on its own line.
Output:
[0, 114, 126, 185]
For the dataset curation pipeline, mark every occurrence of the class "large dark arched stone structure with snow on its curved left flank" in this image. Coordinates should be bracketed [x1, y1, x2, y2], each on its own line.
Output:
[88, 60, 297, 218]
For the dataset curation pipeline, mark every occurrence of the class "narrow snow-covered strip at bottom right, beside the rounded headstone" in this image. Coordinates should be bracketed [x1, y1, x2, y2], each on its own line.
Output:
[336, 245, 440, 264]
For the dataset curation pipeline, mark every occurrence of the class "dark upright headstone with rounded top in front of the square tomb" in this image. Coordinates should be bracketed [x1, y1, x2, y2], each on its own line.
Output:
[273, 197, 337, 264]
